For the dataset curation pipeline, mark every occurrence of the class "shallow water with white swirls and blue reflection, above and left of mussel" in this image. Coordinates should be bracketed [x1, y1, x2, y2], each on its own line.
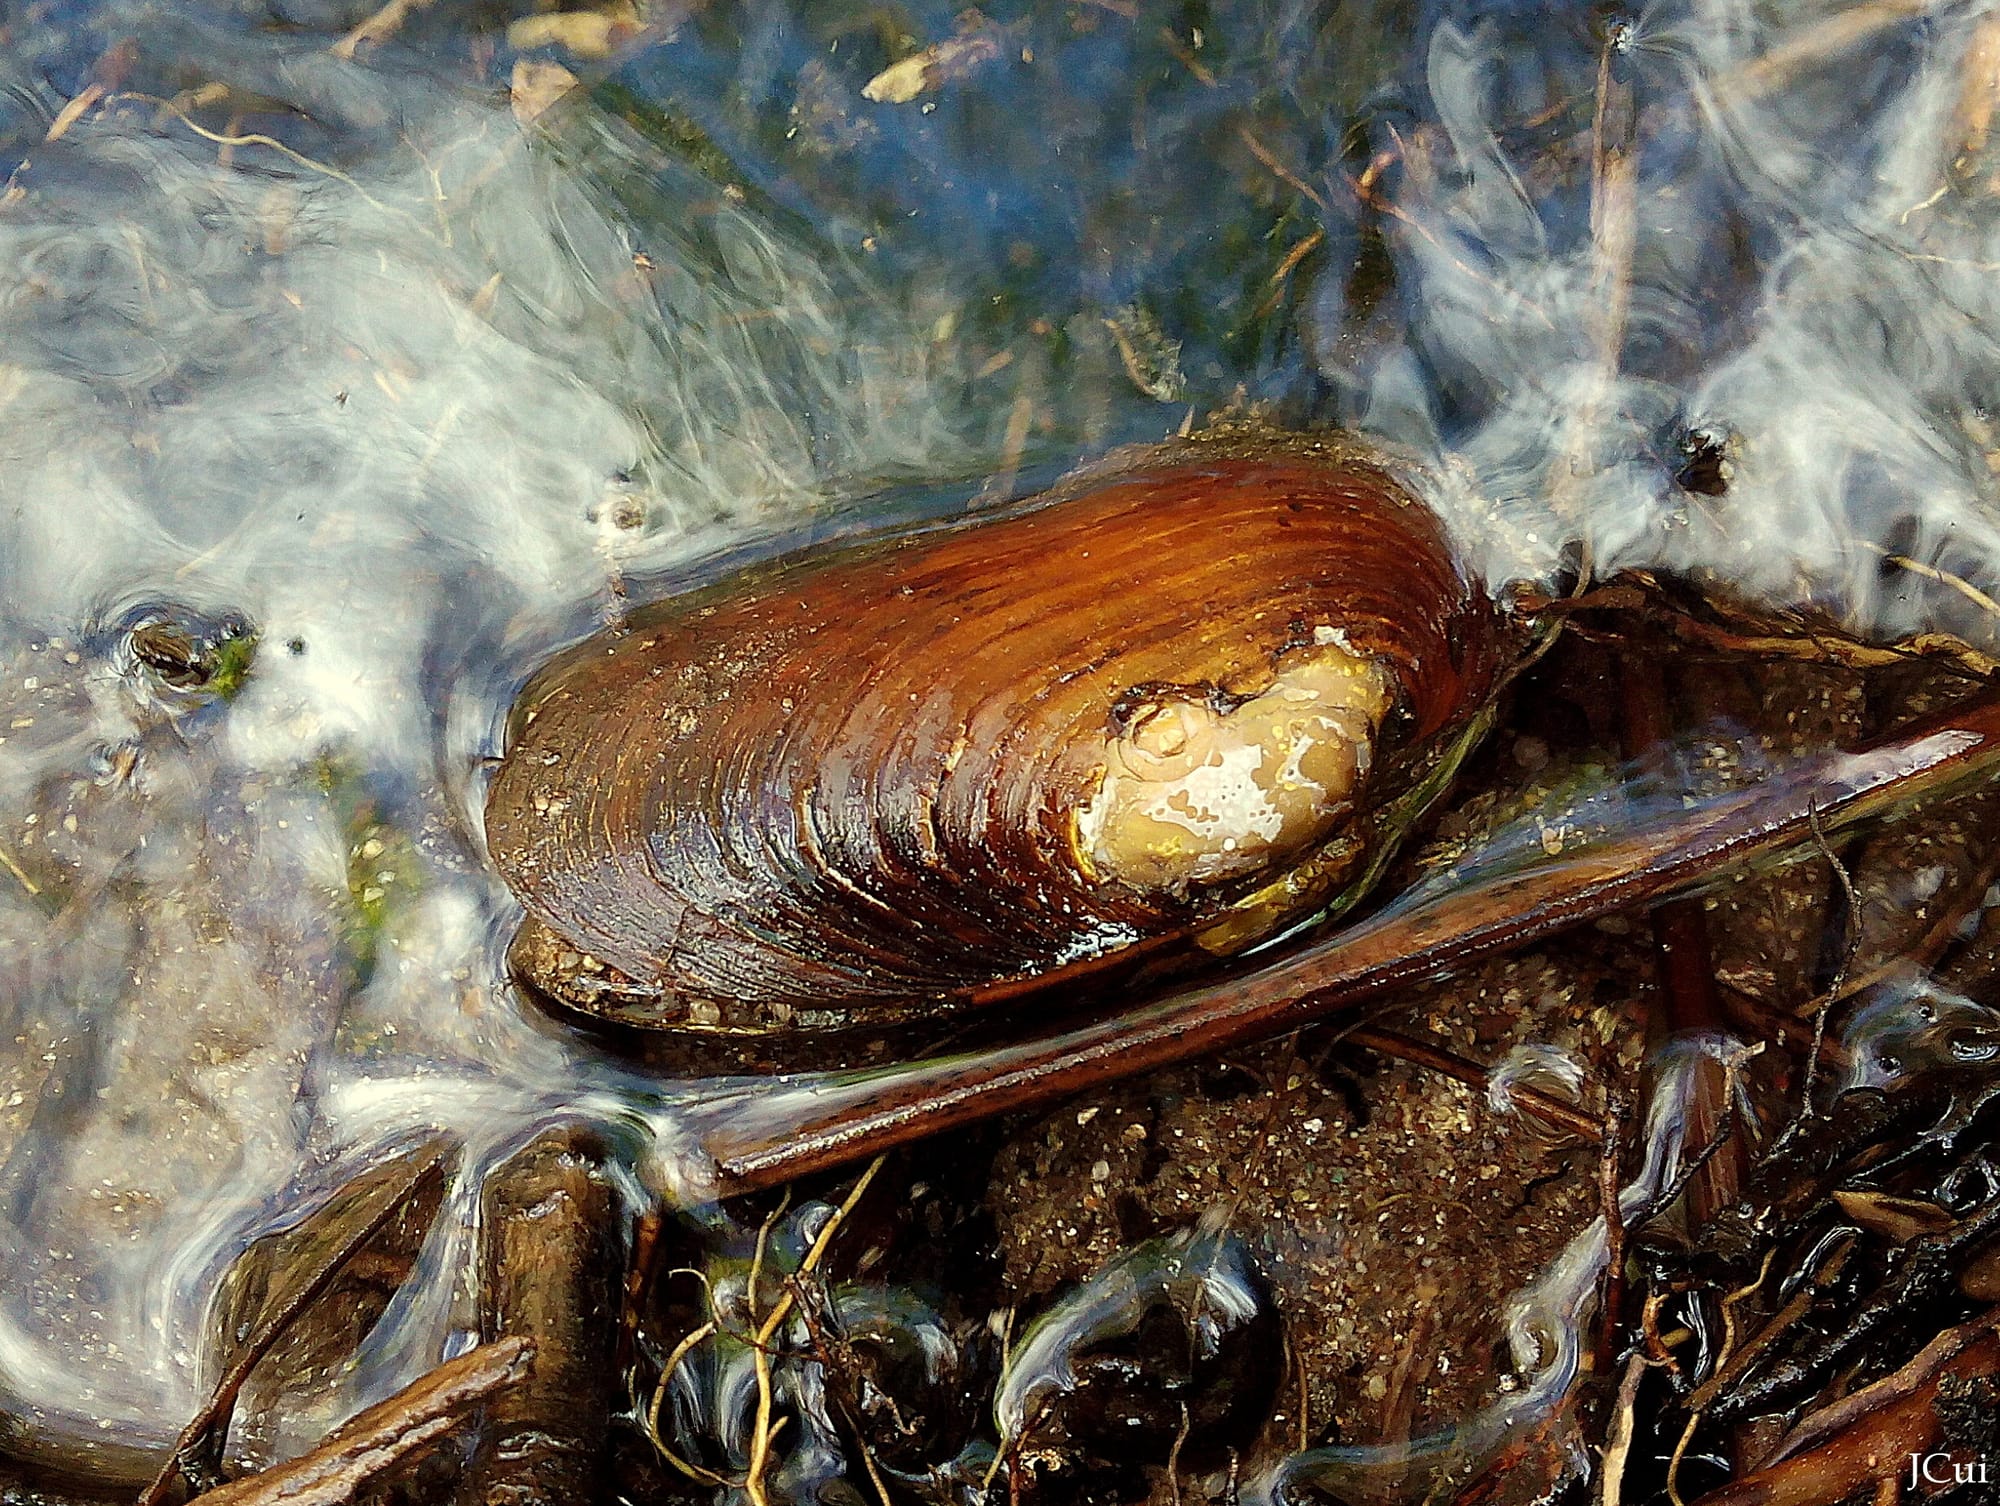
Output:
[0, 2, 2000, 1488]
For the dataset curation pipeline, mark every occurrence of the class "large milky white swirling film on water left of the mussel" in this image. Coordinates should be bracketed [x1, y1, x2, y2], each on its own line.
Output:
[0, 50, 964, 1446]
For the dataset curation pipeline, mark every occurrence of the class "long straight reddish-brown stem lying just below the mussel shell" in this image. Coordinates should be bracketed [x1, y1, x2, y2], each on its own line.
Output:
[704, 700, 2000, 1190]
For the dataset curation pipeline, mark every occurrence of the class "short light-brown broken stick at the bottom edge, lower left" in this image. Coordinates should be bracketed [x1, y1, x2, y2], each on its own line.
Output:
[185, 1338, 534, 1506]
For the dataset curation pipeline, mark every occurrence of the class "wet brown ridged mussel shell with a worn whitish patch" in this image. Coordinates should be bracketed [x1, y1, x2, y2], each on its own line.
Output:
[486, 430, 1502, 1032]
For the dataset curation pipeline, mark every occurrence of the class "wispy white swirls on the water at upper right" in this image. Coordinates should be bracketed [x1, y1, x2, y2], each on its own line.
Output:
[1358, 4, 2000, 638]
